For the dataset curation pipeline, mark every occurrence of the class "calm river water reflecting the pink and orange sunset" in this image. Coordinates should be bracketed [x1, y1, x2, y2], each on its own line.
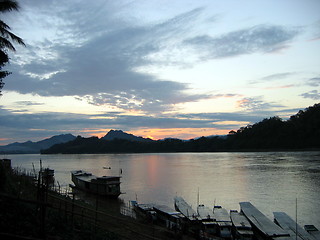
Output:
[6, 152, 320, 228]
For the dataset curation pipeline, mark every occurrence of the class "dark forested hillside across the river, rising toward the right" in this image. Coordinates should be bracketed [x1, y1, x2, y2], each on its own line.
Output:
[42, 104, 320, 154]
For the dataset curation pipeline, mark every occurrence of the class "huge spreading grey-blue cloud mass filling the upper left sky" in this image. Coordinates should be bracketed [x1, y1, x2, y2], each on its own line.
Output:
[6, 2, 209, 112]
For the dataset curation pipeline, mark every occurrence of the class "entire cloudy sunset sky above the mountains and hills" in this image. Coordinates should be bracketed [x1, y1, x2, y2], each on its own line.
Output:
[0, 0, 320, 145]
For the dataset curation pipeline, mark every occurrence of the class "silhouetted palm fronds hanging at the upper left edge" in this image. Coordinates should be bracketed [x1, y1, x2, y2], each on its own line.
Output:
[0, 0, 25, 95]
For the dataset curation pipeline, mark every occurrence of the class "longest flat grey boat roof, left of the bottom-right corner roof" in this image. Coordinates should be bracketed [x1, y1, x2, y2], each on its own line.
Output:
[240, 202, 290, 238]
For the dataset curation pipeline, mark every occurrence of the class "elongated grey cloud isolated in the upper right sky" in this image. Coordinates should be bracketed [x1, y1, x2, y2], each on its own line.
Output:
[185, 25, 299, 60]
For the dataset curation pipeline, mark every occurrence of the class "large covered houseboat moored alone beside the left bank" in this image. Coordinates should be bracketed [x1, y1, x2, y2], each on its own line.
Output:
[71, 170, 121, 198]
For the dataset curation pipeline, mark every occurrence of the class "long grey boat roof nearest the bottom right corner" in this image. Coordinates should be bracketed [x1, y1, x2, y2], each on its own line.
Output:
[273, 212, 314, 240]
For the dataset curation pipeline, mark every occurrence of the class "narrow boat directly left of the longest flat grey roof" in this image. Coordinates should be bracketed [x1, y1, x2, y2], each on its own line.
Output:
[230, 210, 253, 240]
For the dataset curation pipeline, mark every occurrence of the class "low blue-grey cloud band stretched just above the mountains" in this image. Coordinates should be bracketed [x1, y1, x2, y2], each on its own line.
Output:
[0, 103, 288, 142]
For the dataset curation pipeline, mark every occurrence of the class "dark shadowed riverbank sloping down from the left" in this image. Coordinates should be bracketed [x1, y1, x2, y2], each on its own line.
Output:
[0, 159, 192, 240]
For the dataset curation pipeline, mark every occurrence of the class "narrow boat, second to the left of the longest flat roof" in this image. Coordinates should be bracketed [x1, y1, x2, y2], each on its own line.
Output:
[213, 206, 232, 239]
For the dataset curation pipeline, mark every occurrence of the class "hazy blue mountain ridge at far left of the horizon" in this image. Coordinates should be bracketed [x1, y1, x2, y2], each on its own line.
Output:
[0, 134, 76, 154]
